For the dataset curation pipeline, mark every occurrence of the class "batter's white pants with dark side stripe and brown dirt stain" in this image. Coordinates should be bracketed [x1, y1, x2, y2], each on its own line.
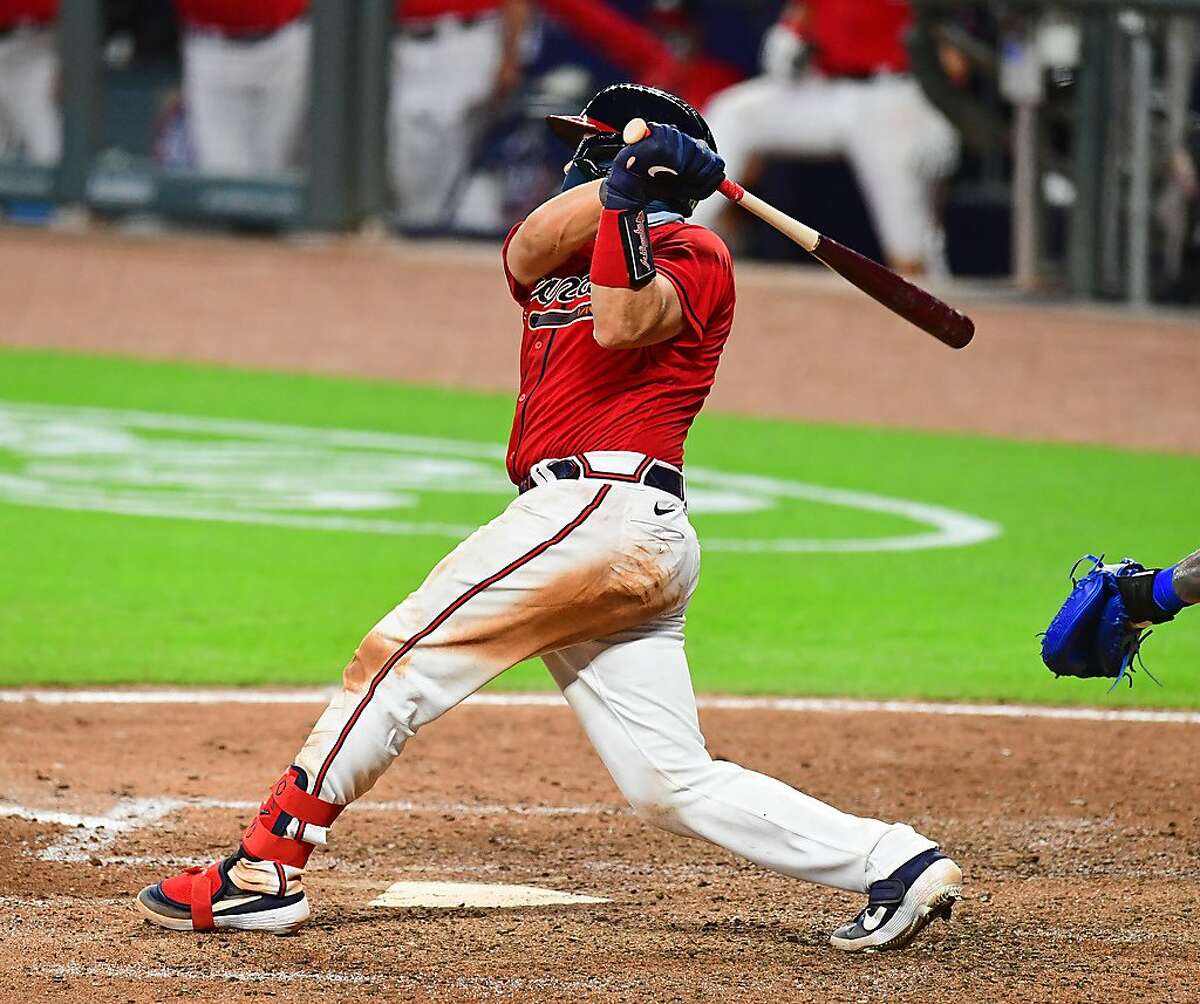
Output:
[283, 453, 935, 891]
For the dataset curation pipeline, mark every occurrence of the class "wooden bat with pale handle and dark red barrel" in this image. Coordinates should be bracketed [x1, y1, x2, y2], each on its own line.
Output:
[622, 119, 974, 349]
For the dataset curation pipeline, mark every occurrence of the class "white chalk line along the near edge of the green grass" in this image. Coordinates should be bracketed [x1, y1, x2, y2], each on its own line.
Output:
[0, 689, 1200, 725]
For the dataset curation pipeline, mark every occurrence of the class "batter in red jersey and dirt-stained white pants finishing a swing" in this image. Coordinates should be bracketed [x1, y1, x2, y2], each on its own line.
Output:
[137, 84, 962, 951]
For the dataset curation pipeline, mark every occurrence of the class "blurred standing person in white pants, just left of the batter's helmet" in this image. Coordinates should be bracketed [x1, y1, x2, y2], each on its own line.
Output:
[388, 0, 529, 229]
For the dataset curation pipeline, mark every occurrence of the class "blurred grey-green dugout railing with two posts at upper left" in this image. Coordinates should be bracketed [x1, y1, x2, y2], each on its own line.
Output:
[0, 0, 394, 230]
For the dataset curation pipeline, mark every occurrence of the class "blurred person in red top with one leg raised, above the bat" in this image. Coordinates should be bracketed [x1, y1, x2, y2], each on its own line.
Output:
[694, 0, 959, 273]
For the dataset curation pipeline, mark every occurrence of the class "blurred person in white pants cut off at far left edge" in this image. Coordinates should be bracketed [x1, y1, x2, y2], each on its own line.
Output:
[0, 0, 62, 164]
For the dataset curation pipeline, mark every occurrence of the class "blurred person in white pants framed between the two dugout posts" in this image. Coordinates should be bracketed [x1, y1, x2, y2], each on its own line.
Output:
[175, 0, 312, 176]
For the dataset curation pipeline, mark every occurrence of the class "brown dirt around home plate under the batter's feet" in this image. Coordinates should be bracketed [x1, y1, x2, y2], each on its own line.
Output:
[0, 702, 1200, 1004]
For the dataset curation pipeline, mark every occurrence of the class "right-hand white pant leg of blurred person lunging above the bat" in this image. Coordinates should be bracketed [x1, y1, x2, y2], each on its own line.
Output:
[847, 77, 959, 272]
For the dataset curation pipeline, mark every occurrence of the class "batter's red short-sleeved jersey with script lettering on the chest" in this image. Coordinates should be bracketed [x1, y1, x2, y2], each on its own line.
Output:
[504, 222, 734, 485]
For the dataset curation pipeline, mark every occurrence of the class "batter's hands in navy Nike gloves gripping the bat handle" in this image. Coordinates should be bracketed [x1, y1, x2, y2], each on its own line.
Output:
[602, 122, 725, 209]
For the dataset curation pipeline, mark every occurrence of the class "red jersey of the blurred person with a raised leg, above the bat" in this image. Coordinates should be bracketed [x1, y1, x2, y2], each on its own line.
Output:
[790, 0, 912, 77]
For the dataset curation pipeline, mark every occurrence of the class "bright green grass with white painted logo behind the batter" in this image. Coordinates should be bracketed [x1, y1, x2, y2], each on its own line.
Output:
[0, 350, 1200, 707]
